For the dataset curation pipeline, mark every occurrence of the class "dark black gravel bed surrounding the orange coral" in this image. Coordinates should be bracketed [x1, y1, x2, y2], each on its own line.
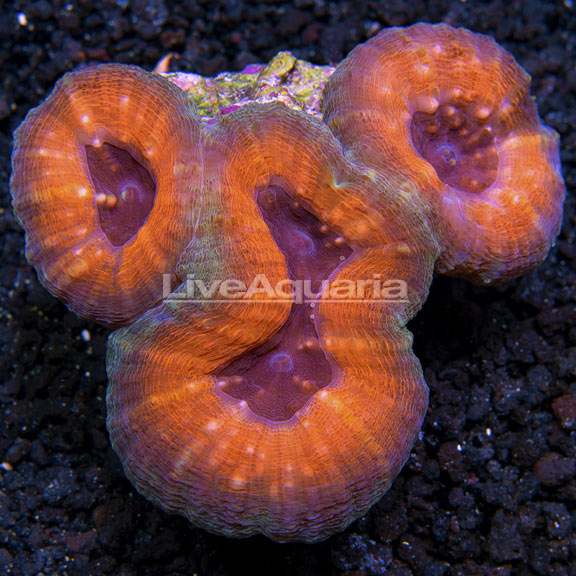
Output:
[0, 0, 576, 576]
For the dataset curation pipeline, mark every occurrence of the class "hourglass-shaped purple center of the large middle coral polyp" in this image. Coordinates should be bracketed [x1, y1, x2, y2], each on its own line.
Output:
[216, 186, 352, 421]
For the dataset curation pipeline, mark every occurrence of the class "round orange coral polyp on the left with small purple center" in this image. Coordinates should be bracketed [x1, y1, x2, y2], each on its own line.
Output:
[10, 65, 201, 326]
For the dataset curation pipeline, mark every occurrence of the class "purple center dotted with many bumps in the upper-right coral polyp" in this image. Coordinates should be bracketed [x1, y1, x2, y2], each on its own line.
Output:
[411, 105, 498, 193]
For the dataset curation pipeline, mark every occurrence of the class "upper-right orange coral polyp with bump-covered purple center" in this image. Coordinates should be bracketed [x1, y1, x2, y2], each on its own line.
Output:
[324, 24, 564, 283]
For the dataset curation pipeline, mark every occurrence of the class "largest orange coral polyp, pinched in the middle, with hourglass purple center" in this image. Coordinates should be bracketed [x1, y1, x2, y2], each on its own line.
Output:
[108, 105, 437, 540]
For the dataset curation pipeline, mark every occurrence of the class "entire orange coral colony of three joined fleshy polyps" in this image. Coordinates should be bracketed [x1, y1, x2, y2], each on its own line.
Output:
[11, 25, 564, 541]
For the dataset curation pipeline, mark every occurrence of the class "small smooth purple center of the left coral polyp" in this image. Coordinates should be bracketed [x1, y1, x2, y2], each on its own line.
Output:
[85, 142, 156, 246]
